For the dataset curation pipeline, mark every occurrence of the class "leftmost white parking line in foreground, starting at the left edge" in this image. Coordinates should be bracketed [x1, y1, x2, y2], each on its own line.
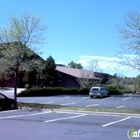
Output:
[0, 111, 52, 120]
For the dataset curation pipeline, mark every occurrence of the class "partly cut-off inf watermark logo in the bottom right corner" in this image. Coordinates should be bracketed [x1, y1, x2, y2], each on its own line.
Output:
[127, 128, 140, 140]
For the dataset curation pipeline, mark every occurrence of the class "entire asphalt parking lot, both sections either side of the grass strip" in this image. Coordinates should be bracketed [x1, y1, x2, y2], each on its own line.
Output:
[0, 90, 140, 140]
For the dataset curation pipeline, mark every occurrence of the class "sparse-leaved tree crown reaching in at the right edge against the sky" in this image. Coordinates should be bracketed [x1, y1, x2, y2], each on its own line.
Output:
[117, 11, 140, 70]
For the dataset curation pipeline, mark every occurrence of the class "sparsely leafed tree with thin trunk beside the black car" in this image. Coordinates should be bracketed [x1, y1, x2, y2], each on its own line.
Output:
[0, 13, 46, 100]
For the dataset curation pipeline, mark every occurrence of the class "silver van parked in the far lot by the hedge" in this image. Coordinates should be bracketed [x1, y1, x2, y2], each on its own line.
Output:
[89, 87, 109, 98]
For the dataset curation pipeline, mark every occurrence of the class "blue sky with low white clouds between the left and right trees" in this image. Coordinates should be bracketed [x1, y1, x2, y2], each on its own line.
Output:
[0, 0, 140, 77]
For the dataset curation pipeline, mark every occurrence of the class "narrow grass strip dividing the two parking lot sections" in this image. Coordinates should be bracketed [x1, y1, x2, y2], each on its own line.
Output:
[18, 103, 140, 114]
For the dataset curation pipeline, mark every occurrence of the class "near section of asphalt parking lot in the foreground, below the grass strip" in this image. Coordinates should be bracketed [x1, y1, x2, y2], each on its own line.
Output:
[0, 110, 140, 140]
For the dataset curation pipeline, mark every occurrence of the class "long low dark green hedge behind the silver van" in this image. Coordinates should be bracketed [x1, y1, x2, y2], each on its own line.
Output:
[18, 86, 132, 97]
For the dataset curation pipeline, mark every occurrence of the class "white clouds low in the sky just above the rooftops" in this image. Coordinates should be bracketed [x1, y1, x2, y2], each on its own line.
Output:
[56, 55, 138, 77]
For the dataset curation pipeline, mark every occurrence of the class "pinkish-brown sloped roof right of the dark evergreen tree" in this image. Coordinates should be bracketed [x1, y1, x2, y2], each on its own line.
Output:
[56, 66, 99, 79]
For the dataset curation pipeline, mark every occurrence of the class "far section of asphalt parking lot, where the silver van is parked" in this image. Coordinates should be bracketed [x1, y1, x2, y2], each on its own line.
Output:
[18, 95, 140, 109]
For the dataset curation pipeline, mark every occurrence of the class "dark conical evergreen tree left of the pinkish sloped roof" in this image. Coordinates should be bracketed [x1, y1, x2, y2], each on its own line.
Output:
[41, 56, 60, 86]
